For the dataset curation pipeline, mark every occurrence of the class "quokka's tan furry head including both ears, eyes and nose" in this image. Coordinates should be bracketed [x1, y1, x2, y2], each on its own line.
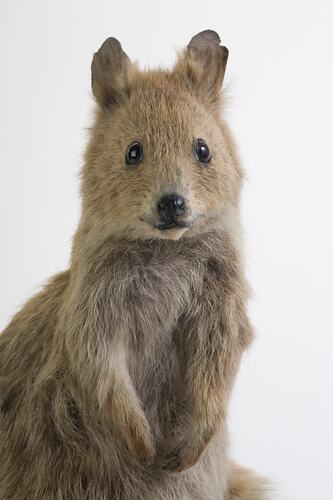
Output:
[82, 30, 242, 240]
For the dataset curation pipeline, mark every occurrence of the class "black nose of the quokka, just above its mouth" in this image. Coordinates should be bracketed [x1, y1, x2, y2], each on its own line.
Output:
[157, 193, 188, 231]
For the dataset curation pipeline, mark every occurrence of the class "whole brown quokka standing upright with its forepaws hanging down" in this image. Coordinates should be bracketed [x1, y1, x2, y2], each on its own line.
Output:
[0, 30, 268, 500]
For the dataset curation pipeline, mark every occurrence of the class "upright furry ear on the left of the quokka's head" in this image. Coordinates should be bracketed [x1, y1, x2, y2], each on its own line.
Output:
[91, 37, 133, 107]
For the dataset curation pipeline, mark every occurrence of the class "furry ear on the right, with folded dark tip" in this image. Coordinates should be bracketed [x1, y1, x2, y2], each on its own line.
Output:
[175, 30, 229, 100]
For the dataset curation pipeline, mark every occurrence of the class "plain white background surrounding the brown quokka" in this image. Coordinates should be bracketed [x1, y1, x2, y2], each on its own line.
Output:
[0, 0, 333, 500]
